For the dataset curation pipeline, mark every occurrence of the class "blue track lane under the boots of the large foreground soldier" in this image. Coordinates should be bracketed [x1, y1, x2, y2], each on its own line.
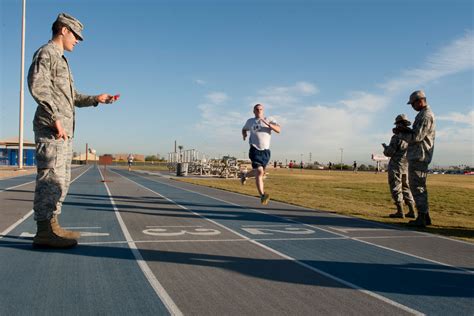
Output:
[0, 168, 168, 315]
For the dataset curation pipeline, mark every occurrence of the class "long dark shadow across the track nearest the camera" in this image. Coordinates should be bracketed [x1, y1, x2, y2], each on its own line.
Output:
[0, 241, 474, 299]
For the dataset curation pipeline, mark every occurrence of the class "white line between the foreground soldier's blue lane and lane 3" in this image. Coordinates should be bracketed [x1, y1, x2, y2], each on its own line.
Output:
[97, 168, 183, 316]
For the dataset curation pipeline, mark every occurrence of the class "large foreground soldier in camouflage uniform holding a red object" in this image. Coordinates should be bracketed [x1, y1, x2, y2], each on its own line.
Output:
[28, 13, 114, 248]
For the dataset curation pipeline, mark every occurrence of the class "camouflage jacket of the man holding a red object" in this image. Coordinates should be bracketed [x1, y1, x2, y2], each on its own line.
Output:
[28, 41, 98, 142]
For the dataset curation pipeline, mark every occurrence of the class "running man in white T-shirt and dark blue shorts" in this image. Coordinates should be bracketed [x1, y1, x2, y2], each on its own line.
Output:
[240, 104, 281, 205]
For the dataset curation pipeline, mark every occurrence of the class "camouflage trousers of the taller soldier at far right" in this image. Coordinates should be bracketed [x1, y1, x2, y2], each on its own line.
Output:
[408, 161, 429, 214]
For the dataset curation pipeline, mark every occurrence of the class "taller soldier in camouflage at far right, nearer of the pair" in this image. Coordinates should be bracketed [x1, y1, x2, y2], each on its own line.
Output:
[394, 90, 436, 227]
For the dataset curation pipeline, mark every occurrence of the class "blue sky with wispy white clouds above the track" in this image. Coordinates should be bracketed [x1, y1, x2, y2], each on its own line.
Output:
[0, 0, 474, 166]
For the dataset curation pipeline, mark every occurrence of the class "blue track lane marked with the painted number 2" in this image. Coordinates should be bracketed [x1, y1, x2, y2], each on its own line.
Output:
[116, 171, 474, 315]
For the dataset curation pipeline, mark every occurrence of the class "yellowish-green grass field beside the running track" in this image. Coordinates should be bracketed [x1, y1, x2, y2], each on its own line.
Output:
[171, 169, 474, 242]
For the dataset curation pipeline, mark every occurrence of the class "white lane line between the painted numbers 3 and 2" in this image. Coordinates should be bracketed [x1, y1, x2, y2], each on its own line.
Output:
[112, 171, 424, 315]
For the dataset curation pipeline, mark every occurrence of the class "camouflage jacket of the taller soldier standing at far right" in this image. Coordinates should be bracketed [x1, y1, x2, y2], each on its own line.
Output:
[399, 106, 436, 164]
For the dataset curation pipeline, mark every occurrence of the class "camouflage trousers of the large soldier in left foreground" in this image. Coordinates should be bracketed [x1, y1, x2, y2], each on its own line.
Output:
[33, 139, 72, 221]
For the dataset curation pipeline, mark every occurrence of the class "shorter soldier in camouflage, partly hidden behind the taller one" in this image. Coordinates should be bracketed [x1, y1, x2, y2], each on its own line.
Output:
[382, 114, 415, 218]
